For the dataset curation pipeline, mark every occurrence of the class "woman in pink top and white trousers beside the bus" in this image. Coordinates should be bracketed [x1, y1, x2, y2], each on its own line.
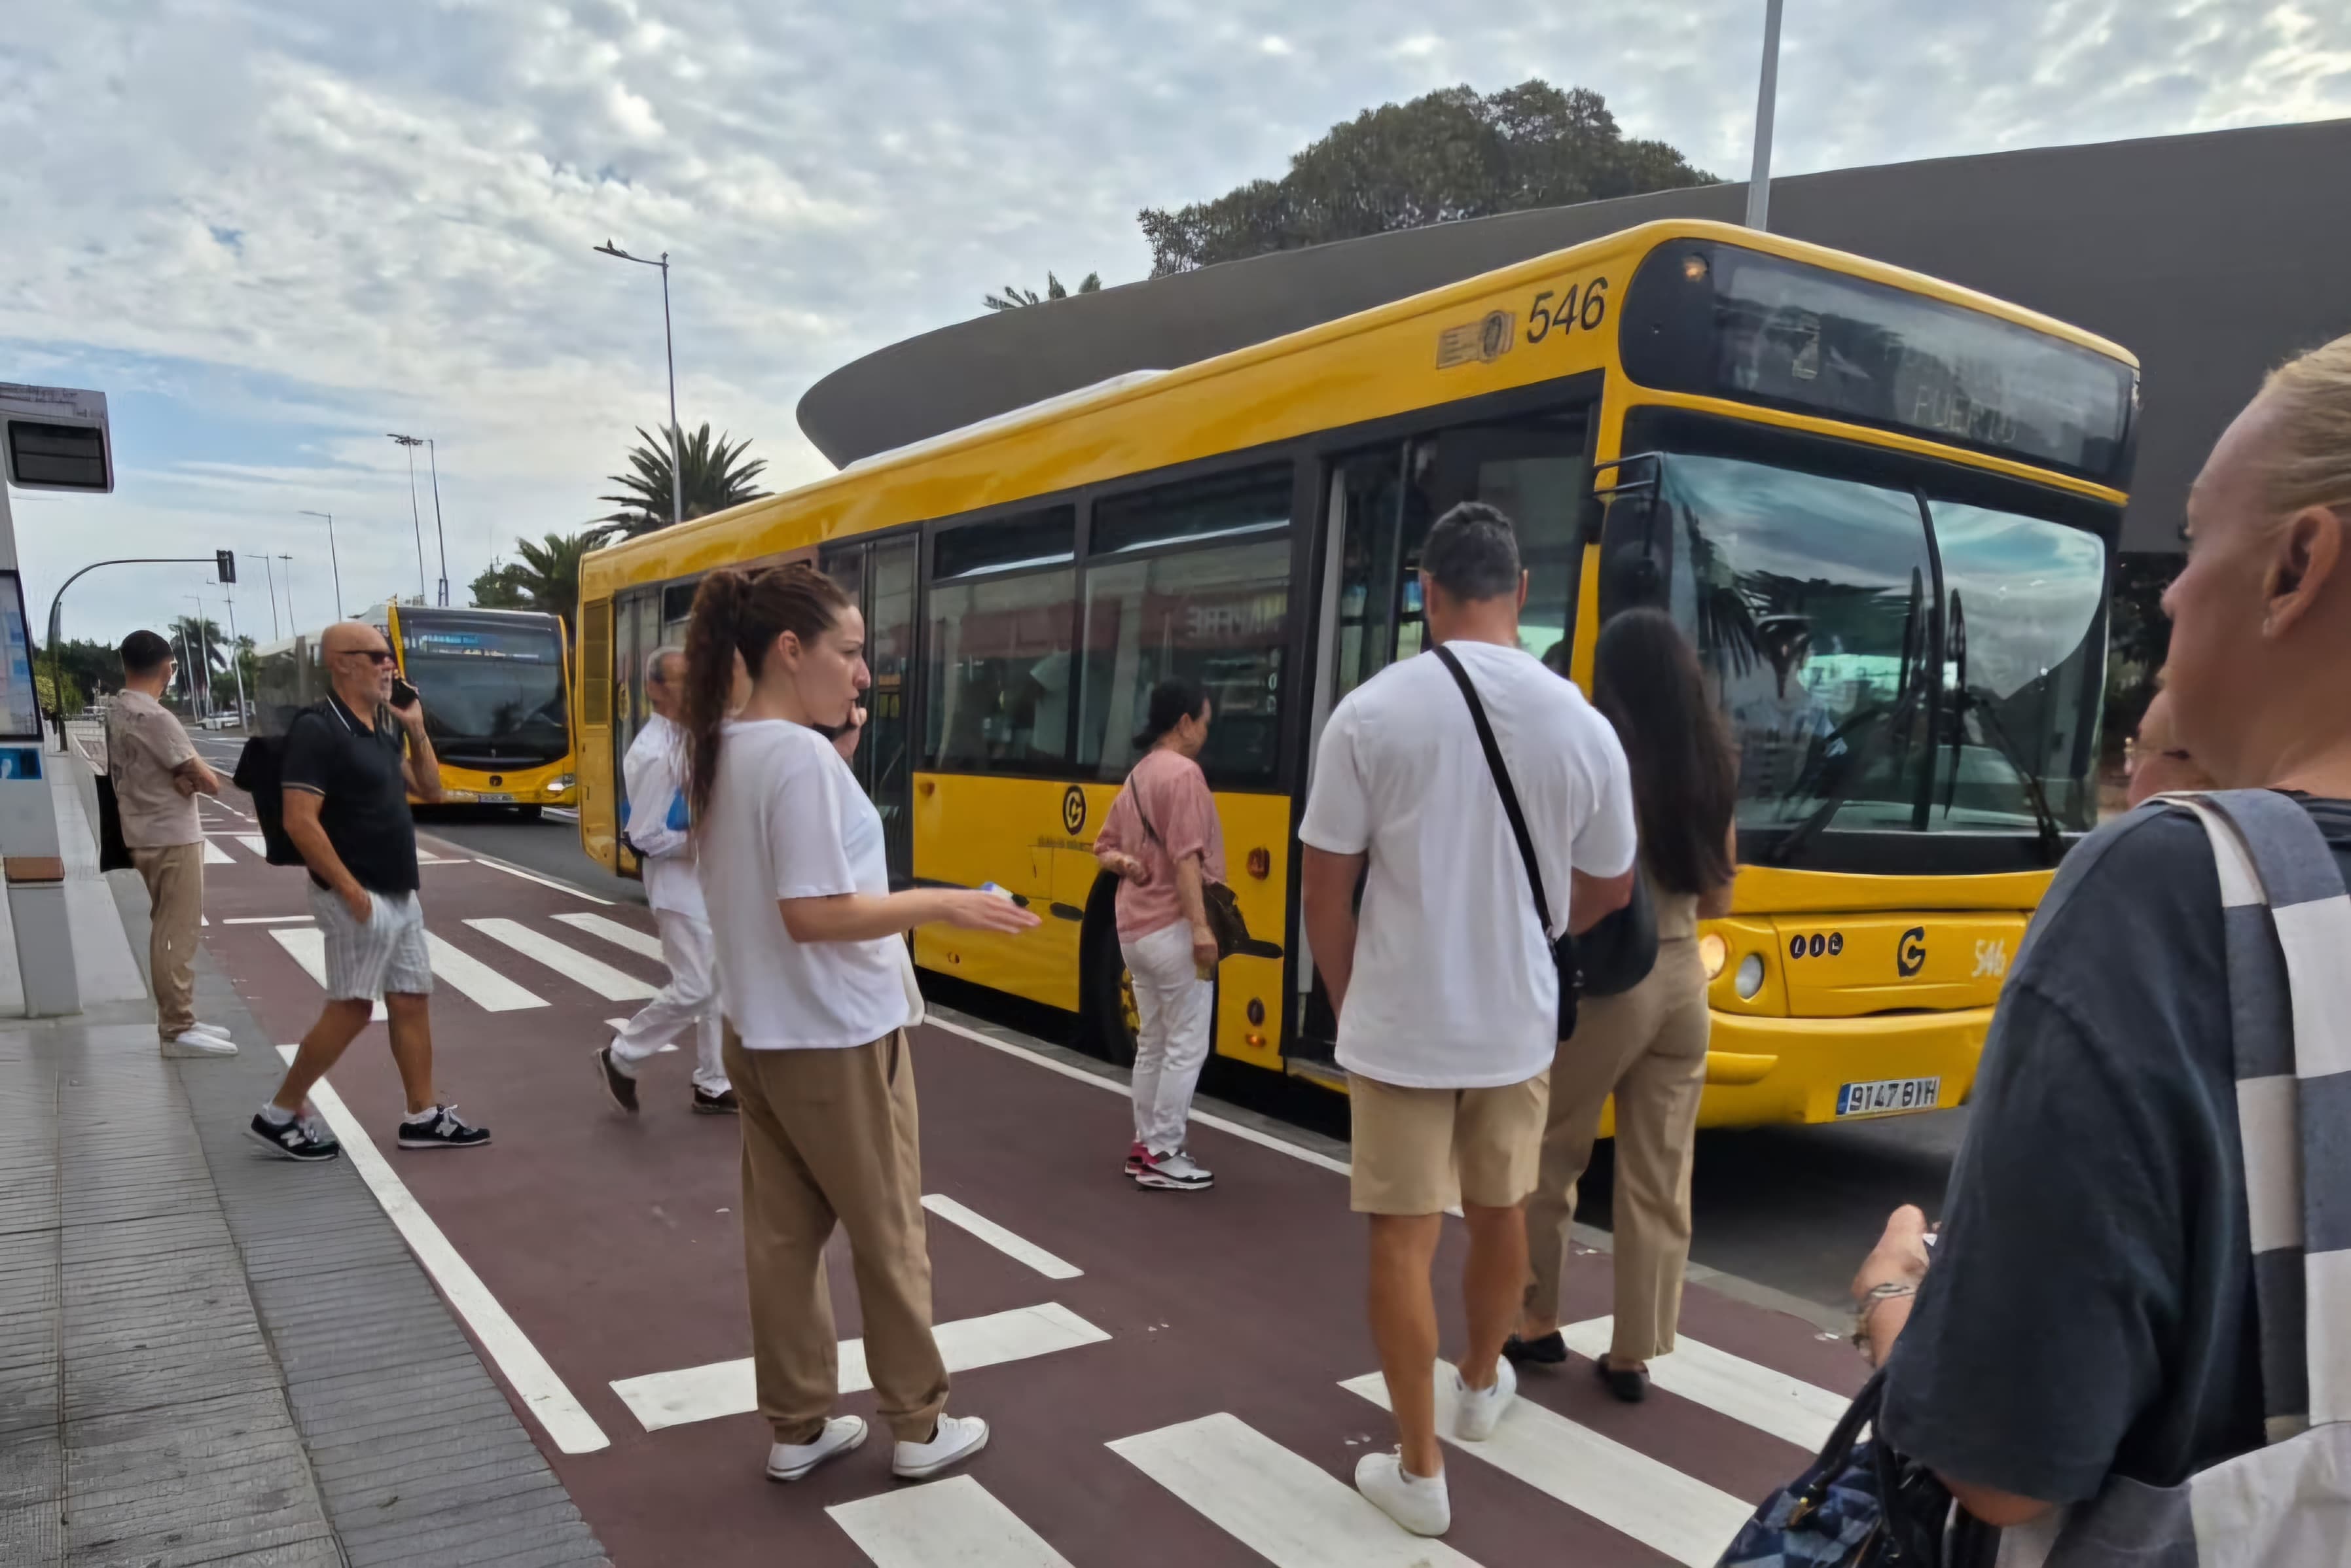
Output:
[1093, 679, 1225, 1192]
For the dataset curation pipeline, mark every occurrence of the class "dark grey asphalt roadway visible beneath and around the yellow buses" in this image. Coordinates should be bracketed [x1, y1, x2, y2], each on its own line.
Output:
[198, 736, 1968, 1307]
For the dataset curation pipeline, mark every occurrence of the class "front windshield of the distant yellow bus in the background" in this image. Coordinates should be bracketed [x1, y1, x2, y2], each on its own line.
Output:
[400, 611, 571, 769]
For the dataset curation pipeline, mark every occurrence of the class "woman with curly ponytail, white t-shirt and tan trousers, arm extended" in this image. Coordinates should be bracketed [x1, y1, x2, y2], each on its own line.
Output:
[684, 562, 1037, 1481]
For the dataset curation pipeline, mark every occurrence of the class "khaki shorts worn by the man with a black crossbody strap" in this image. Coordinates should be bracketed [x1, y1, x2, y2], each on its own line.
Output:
[1347, 1072, 1552, 1215]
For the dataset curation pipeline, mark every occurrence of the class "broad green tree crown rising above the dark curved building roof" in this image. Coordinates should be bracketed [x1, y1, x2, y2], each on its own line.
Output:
[1138, 80, 1714, 277]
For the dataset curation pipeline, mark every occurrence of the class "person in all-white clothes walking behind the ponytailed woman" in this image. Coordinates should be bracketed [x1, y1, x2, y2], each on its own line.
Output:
[595, 647, 740, 1116]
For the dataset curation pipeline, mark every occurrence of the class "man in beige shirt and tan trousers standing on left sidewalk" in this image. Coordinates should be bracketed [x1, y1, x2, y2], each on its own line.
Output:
[106, 632, 238, 1056]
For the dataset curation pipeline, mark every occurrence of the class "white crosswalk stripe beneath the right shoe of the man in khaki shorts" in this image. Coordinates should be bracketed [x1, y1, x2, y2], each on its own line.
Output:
[1340, 1361, 1754, 1568]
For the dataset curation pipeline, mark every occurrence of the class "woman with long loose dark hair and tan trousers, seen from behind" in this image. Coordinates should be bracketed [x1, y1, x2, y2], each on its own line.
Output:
[1505, 609, 1737, 1399]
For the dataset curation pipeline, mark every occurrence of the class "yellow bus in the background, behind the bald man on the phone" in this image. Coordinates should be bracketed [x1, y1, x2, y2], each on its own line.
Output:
[254, 602, 579, 818]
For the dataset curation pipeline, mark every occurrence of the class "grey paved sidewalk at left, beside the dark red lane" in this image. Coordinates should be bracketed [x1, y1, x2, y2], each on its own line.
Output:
[0, 755, 607, 1568]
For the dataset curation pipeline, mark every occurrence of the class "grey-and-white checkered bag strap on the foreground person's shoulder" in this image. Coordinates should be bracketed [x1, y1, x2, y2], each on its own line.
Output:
[2175, 790, 2351, 1441]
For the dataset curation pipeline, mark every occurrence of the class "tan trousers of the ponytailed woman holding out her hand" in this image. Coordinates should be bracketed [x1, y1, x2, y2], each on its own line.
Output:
[722, 1025, 948, 1444]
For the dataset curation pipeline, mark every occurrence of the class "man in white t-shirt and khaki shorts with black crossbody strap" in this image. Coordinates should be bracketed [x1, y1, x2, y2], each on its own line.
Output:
[1298, 503, 1634, 1535]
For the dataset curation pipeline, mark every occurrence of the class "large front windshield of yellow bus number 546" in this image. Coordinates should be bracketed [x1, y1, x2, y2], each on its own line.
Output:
[1657, 454, 2106, 851]
